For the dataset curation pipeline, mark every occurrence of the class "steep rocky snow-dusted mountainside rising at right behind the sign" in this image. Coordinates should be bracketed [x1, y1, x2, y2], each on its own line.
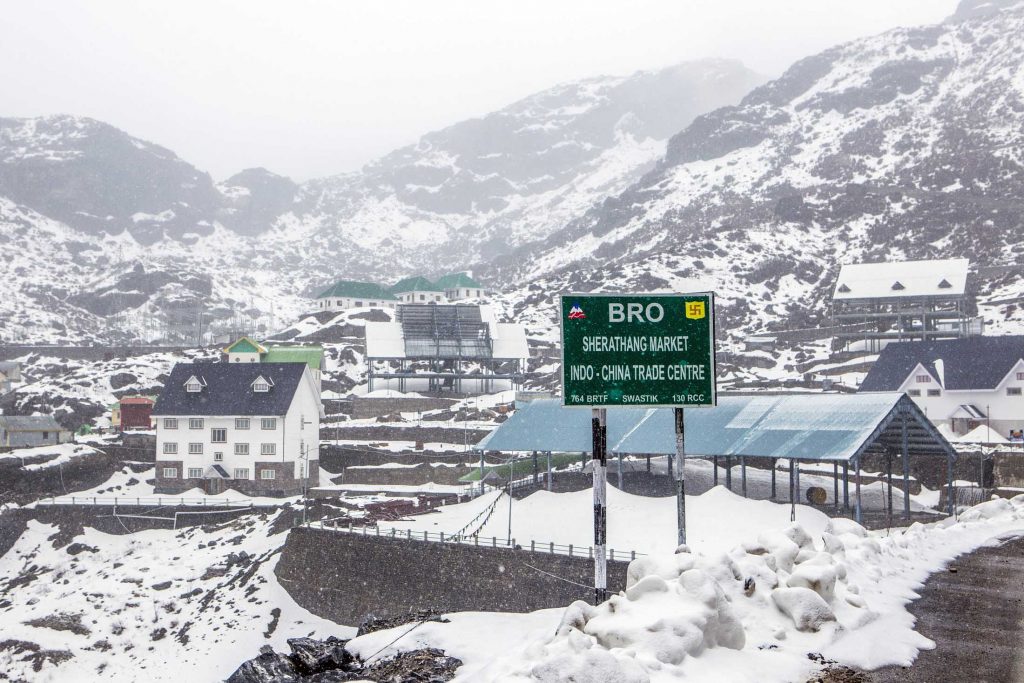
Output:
[486, 1, 1024, 344]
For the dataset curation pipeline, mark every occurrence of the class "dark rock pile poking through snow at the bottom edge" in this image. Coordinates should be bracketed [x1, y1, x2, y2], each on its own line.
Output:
[227, 636, 462, 683]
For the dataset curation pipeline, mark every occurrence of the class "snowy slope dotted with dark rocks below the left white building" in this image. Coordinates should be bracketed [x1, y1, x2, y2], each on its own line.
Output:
[0, 517, 346, 682]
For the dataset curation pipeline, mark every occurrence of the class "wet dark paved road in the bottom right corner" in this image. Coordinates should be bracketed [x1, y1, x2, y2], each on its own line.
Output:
[870, 538, 1024, 683]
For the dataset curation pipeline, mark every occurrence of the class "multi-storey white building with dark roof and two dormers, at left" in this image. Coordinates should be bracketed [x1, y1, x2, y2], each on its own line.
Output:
[153, 362, 324, 496]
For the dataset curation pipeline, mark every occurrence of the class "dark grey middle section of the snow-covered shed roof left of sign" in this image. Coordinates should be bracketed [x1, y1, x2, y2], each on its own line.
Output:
[397, 304, 492, 358]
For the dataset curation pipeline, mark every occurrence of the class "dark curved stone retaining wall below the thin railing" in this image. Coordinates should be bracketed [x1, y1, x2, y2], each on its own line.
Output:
[275, 527, 628, 626]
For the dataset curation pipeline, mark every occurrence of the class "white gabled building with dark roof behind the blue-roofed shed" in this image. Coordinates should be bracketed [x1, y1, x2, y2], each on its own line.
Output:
[860, 336, 1024, 437]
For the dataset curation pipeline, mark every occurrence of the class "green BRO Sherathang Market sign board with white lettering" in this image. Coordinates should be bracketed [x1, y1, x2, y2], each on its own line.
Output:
[560, 292, 716, 408]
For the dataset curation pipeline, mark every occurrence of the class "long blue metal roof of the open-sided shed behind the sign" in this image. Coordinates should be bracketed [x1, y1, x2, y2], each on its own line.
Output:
[476, 392, 949, 462]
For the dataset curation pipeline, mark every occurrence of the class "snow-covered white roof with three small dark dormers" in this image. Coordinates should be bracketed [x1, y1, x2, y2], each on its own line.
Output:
[833, 258, 971, 301]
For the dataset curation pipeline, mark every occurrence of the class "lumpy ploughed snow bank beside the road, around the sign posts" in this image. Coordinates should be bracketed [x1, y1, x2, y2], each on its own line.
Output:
[349, 489, 1024, 683]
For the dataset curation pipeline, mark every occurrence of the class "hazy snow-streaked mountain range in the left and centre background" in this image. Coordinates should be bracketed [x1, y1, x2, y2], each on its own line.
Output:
[0, 60, 763, 341]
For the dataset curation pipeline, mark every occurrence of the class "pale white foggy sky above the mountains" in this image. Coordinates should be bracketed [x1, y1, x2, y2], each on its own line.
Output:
[0, 0, 956, 180]
